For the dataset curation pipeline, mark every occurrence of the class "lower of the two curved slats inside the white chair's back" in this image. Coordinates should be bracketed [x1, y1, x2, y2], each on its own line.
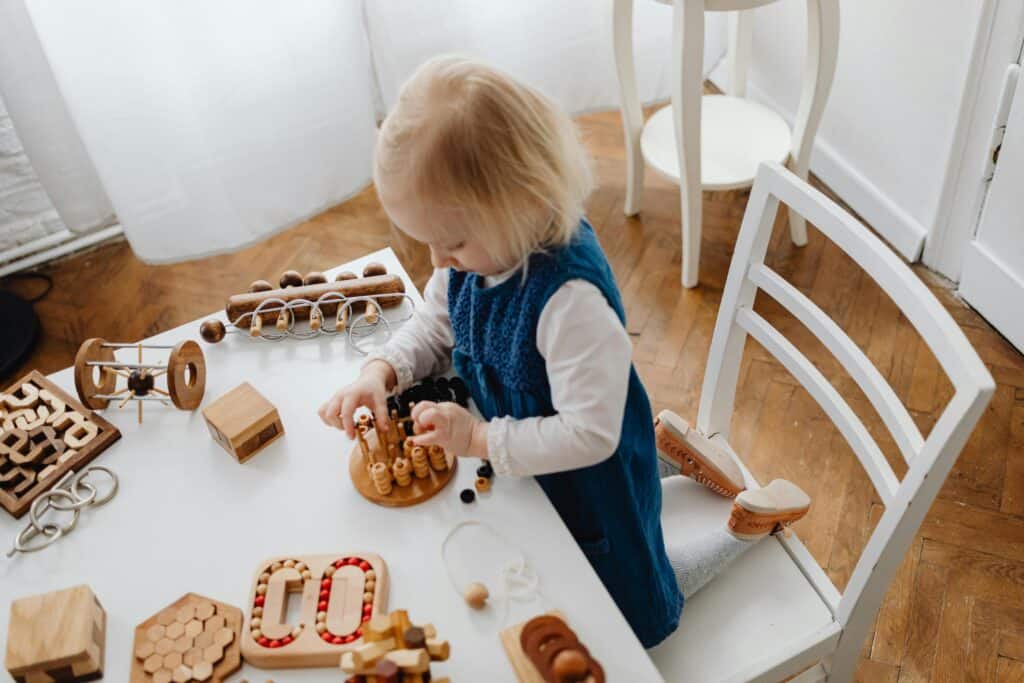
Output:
[736, 308, 899, 506]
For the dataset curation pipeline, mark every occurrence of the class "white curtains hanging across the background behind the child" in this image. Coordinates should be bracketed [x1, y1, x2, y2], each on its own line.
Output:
[12, 0, 725, 262]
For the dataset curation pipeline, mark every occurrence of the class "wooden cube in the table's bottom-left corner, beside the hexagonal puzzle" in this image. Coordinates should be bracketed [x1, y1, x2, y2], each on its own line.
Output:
[4, 585, 106, 683]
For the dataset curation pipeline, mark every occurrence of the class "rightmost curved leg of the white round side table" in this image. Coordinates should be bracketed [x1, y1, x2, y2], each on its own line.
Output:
[790, 0, 839, 247]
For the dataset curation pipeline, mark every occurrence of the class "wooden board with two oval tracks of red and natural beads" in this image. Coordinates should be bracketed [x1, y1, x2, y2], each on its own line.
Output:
[242, 553, 387, 669]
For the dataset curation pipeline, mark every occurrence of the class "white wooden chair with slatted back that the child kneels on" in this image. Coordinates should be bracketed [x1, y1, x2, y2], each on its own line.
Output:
[651, 164, 994, 683]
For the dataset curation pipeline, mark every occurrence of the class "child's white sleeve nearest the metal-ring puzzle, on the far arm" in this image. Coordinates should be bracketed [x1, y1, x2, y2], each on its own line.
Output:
[364, 268, 455, 391]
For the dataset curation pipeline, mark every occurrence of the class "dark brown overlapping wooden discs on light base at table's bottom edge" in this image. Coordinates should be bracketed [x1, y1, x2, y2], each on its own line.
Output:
[501, 611, 604, 683]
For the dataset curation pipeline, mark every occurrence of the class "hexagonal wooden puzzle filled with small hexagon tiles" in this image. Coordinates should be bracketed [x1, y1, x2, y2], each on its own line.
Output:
[131, 593, 242, 683]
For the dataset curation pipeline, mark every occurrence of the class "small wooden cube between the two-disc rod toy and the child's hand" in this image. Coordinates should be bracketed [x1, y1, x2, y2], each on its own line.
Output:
[203, 382, 285, 463]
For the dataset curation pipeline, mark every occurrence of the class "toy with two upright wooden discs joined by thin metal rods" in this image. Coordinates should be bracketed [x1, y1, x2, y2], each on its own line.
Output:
[75, 338, 206, 423]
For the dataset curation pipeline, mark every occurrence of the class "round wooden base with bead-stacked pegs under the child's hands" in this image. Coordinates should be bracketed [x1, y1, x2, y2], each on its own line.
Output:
[348, 412, 458, 508]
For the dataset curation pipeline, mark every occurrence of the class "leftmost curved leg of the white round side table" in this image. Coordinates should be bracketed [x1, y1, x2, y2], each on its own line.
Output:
[612, 0, 643, 216]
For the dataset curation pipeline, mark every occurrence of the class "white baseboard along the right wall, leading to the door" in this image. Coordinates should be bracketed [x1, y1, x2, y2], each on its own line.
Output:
[708, 59, 928, 261]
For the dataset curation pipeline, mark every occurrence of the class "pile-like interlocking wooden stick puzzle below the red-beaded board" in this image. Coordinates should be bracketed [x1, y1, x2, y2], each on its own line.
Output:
[341, 609, 450, 683]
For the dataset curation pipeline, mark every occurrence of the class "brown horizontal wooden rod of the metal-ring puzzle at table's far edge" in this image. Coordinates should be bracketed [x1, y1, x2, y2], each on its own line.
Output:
[224, 274, 406, 327]
